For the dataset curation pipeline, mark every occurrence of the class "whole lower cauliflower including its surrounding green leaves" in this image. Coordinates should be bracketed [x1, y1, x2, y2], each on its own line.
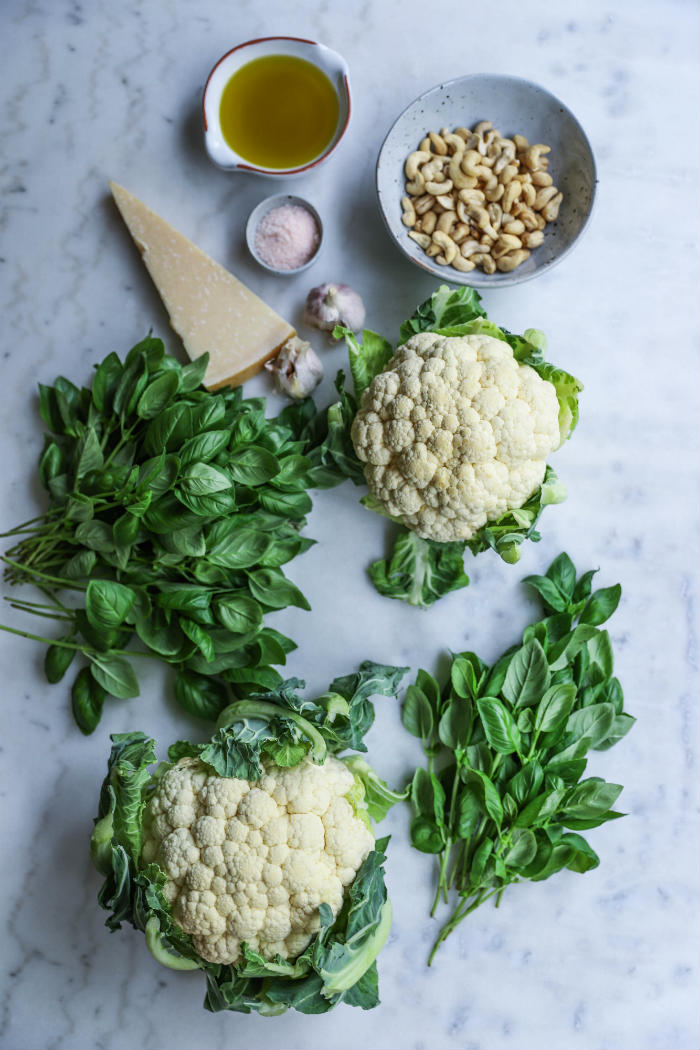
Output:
[90, 662, 407, 1014]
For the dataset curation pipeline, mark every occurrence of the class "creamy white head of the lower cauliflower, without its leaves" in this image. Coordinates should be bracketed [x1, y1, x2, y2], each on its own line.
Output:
[141, 757, 375, 964]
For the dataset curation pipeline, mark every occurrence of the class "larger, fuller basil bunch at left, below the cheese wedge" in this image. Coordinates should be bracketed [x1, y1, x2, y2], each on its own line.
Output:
[2, 336, 336, 733]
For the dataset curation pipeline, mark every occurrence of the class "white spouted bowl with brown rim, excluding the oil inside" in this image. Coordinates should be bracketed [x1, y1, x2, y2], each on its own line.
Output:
[201, 37, 351, 179]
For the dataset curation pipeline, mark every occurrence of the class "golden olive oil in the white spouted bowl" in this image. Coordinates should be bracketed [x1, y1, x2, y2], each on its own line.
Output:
[219, 55, 338, 169]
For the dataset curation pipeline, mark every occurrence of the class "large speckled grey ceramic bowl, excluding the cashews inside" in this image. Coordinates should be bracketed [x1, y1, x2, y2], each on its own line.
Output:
[377, 74, 596, 288]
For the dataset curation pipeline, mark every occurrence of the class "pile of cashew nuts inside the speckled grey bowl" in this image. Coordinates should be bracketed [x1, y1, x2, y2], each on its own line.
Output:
[401, 121, 563, 273]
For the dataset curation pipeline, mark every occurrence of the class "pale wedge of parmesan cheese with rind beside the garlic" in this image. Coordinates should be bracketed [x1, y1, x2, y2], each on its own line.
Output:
[109, 183, 296, 390]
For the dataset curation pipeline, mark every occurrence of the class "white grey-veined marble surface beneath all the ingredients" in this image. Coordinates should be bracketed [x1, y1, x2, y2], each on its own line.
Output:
[0, 0, 699, 1050]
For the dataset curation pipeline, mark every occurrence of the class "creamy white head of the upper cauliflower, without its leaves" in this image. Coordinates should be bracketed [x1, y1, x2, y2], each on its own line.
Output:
[351, 332, 560, 543]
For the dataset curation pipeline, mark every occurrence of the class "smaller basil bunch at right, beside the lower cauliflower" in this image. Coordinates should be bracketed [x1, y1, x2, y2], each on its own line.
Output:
[402, 553, 635, 962]
